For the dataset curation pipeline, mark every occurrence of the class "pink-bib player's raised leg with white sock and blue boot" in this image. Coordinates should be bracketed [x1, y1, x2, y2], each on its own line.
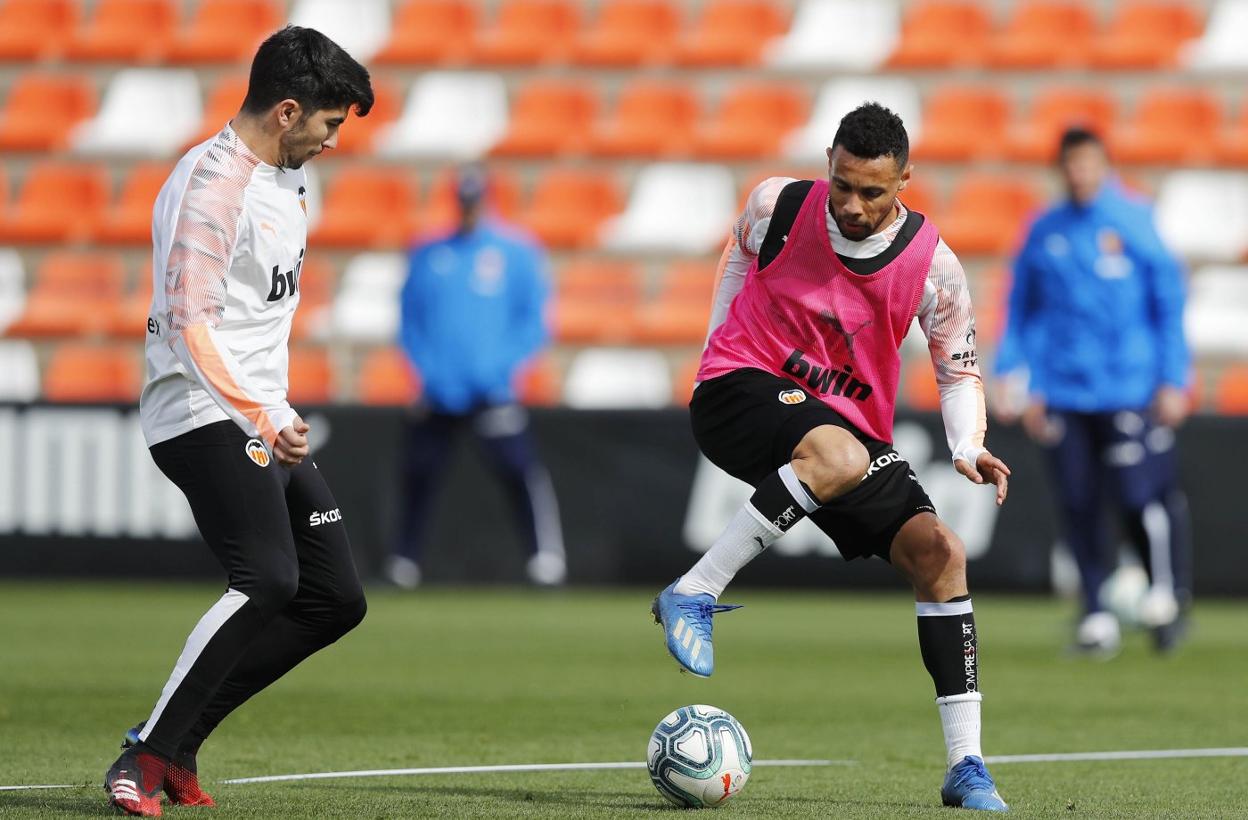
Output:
[653, 424, 869, 676]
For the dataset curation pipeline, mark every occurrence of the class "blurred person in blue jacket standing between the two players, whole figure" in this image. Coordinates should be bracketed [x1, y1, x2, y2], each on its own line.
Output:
[387, 165, 567, 588]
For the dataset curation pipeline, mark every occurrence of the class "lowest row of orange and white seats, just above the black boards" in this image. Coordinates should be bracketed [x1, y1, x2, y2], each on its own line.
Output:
[9, 339, 1248, 414]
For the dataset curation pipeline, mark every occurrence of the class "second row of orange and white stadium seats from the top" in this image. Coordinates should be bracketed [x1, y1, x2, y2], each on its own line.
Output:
[7, 69, 1248, 165]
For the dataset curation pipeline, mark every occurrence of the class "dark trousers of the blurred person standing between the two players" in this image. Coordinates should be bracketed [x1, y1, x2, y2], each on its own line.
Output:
[396, 404, 563, 563]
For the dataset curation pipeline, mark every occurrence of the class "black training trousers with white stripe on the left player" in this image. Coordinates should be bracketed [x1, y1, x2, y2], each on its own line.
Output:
[141, 422, 364, 756]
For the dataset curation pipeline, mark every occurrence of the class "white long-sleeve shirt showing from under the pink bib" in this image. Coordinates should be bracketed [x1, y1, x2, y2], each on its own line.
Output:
[708, 177, 987, 466]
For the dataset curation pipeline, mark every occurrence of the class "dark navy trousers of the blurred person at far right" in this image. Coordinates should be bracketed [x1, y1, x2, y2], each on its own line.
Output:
[1048, 409, 1192, 613]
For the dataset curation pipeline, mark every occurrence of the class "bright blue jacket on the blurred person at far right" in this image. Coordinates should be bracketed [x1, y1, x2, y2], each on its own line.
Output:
[996, 183, 1191, 412]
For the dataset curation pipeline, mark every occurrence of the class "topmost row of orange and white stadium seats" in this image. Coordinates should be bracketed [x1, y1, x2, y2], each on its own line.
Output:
[0, 0, 1248, 70]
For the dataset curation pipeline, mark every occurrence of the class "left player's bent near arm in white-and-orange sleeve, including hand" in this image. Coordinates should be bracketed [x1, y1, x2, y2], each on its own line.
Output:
[165, 160, 299, 463]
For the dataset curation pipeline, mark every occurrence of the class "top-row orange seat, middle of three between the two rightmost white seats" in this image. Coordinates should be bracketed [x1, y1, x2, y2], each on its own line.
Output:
[987, 0, 1096, 69]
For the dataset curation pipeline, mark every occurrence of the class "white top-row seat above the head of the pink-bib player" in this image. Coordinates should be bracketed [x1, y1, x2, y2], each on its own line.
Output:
[765, 0, 901, 71]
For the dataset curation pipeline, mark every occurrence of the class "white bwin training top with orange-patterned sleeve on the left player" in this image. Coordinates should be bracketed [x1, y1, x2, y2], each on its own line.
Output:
[140, 125, 307, 449]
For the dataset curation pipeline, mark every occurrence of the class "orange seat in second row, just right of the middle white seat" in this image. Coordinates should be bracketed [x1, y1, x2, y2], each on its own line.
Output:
[490, 80, 599, 157]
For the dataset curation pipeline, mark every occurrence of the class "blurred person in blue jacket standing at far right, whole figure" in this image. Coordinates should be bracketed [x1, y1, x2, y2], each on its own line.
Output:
[995, 127, 1191, 654]
